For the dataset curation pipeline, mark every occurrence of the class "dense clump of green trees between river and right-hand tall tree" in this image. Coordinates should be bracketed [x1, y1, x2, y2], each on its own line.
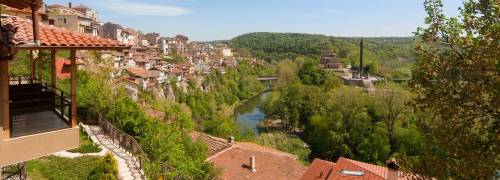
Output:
[264, 58, 423, 165]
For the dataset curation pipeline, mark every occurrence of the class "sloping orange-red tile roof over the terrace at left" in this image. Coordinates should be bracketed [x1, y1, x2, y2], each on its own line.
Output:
[0, 15, 130, 49]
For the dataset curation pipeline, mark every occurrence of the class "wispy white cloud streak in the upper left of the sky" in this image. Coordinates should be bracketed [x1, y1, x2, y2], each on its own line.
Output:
[98, 0, 191, 16]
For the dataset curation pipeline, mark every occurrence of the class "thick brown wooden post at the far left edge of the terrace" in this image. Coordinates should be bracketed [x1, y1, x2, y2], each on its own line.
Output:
[0, 61, 10, 139]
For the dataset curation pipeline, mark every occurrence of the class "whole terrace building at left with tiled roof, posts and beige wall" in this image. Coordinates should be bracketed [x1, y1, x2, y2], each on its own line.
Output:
[0, 0, 129, 173]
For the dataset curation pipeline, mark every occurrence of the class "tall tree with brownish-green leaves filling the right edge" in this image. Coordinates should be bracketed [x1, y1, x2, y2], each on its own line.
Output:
[408, 0, 500, 179]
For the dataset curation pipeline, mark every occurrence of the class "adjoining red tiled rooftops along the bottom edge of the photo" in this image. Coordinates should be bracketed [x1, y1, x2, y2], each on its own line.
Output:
[189, 132, 414, 180]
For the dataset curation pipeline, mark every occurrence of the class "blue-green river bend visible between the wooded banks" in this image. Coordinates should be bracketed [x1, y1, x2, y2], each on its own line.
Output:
[234, 91, 270, 134]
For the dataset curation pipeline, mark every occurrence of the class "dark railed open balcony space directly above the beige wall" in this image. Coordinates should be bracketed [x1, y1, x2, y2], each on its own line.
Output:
[9, 75, 71, 138]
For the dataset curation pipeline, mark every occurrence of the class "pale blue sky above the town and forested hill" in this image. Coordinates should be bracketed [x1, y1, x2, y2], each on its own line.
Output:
[45, 0, 462, 41]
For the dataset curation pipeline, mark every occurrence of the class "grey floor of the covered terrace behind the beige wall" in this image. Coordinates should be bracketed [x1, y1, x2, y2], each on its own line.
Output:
[11, 111, 70, 137]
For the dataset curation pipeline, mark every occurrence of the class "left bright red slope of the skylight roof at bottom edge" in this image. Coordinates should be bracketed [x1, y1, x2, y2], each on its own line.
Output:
[300, 158, 335, 180]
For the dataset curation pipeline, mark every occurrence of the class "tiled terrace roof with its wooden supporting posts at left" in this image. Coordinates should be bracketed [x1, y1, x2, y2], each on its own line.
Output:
[0, 0, 130, 139]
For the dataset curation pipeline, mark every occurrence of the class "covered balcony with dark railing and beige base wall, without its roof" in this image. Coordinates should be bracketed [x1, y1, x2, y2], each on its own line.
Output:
[0, 75, 79, 167]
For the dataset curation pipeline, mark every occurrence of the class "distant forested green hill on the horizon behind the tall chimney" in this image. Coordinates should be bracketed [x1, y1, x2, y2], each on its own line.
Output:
[229, 32, 415, 78]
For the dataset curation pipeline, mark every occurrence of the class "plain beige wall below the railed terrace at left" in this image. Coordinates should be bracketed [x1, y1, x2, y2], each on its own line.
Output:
[0, 127, 80, 167]
